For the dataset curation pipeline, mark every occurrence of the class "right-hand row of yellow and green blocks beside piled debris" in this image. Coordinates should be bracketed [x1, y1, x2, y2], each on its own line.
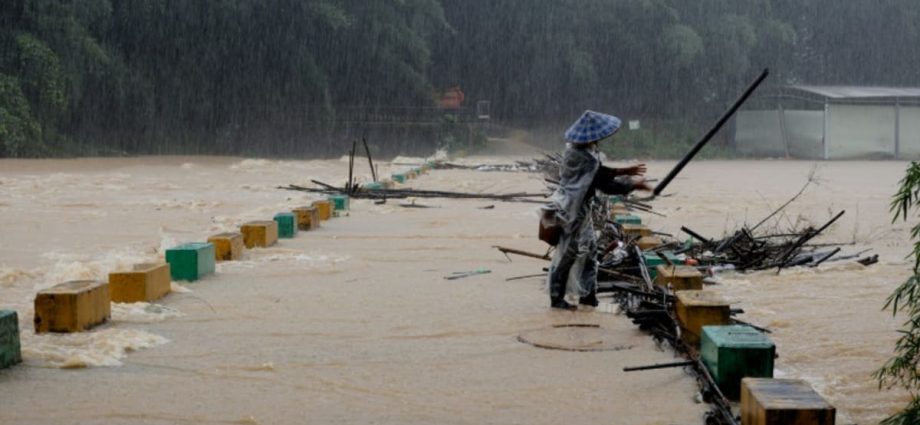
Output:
[611, 198, 836, 425]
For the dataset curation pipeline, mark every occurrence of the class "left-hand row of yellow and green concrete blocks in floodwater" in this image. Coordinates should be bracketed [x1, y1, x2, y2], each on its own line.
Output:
[0, 195, 349, 369]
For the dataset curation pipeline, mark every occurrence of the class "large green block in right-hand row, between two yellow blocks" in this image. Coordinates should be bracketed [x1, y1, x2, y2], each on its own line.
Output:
[700, 325, 776, 400]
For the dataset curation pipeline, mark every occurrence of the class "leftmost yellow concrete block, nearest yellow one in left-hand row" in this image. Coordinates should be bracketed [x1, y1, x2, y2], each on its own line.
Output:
[34, 280, 112, 333]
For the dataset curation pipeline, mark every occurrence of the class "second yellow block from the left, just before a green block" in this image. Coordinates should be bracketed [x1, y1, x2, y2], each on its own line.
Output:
[109, 263, 172, 303]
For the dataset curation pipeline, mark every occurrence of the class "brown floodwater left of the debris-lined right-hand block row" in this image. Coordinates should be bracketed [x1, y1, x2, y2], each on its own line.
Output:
[0, 158, 706, 424]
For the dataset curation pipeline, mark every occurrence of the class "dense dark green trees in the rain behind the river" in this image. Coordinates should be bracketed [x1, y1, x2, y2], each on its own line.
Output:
[0, 0, 920, 157]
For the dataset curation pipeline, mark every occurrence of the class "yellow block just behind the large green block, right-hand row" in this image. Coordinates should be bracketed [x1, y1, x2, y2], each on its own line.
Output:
[674, 290, 731, 347]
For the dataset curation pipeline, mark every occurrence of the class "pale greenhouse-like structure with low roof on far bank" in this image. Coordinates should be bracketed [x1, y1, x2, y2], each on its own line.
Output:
[734, 85, 920, 159]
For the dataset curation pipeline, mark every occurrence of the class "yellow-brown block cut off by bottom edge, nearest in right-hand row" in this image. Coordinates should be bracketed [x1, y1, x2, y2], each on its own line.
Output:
[741, 378, 837, 425]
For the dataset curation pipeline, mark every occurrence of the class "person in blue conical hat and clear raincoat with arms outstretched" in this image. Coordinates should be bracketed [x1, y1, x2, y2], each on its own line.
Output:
[544, 111, 651, 310]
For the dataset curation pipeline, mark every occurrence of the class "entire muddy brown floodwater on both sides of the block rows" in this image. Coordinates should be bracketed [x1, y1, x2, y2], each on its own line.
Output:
[0, 157, 910, 424]
